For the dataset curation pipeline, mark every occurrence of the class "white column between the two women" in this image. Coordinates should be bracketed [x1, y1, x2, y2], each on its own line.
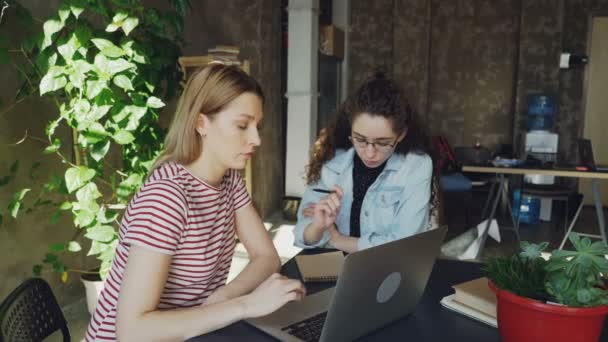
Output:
[285, 0, 319, 196]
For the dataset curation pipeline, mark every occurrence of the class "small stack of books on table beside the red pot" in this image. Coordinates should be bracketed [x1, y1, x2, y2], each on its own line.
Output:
[441, 277, 497, 327]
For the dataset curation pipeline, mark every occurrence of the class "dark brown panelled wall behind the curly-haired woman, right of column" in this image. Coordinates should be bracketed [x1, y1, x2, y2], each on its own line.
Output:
[349, 0, 608, 162]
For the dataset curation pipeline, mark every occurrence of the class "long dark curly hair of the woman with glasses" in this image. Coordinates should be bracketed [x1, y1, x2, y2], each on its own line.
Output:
[306, 71, 433, 184]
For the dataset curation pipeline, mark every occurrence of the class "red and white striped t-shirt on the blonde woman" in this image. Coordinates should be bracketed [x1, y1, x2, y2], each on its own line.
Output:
[86, 162, 251, 341]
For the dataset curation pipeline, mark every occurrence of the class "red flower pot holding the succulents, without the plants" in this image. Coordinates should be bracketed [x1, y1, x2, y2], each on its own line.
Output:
[488, 281, 608, 342]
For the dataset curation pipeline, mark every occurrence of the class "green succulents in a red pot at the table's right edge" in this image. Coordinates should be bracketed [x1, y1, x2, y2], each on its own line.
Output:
[484, 233, 608, 342]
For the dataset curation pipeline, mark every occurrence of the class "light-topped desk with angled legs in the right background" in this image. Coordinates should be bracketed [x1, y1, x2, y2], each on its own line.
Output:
[462, 166, 608, 258]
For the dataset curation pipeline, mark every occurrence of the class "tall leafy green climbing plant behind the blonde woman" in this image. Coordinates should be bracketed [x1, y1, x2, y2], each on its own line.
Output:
[0, 0, 190, 312]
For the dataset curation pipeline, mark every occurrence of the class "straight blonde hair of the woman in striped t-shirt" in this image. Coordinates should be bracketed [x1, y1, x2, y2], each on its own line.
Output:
[152, 64, 264, 169]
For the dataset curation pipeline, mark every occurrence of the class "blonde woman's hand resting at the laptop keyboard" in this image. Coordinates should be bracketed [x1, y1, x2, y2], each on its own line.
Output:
[245, 273, 306, 317]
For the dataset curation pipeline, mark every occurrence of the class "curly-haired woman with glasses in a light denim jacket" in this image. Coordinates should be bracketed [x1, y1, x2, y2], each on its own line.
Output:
[294, 73, 433, 253]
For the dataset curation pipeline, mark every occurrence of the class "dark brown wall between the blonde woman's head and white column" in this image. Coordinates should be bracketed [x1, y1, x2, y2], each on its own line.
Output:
[177, 0, 285, 217]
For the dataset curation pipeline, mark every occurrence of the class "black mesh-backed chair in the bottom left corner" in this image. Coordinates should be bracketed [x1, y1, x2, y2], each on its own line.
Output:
[0, 278, 70, 342]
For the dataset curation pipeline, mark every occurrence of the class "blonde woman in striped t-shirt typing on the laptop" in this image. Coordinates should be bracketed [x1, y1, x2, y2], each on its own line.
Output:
[86, 64, 304, 341]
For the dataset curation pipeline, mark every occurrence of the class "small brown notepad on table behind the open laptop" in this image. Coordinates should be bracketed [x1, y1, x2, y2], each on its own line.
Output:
[296, 251, 344, 282]
